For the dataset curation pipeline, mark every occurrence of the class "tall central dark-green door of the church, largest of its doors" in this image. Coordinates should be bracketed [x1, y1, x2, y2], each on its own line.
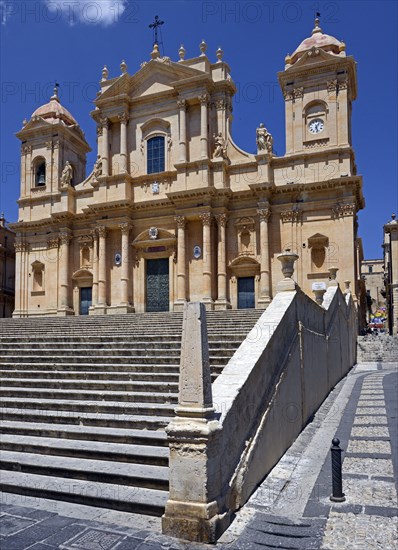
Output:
[146, 258, 170, 311]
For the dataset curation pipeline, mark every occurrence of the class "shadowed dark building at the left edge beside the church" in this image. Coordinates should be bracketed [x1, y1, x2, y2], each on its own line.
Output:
[0, 214, 15, 317]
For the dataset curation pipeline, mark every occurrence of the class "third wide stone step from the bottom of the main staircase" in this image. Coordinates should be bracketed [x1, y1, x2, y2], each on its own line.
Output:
[0, 433, 169, 466]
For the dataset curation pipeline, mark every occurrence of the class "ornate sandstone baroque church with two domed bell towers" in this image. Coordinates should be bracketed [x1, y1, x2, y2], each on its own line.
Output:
[12, 20, 364, 317]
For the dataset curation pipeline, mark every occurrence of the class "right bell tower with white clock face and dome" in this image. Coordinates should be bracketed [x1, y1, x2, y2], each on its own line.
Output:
[278, 18, 357, 155]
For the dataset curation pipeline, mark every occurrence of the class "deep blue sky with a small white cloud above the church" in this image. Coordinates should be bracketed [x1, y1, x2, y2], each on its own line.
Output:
[0, 0, 398, 258]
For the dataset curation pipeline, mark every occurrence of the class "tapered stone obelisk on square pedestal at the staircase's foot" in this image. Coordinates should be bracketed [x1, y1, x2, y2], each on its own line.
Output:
[162, 302, 224, 542]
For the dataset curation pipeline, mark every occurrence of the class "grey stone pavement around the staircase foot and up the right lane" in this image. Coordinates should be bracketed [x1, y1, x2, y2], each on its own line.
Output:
[0, 363, 398, 550]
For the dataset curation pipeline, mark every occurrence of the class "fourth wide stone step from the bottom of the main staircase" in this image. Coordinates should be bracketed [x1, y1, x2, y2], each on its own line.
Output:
[0, 420, 168, 452]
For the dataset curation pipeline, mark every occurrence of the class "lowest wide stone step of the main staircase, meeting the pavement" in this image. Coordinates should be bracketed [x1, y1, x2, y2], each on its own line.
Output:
[0, 471, 168, 517]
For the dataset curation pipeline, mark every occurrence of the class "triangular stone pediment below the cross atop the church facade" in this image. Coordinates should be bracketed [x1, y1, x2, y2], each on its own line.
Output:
[99, 59, 206, 100]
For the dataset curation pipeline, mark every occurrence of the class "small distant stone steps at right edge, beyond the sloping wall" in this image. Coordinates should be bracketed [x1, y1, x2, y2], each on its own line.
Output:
[357, 334, 398, 363]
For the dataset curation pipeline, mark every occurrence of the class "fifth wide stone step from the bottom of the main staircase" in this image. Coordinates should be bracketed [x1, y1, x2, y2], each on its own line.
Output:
[1, 410, 174, 430]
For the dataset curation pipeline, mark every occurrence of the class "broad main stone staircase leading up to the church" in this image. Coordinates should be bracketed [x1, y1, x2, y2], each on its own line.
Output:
[0, 310, 262, 516]
